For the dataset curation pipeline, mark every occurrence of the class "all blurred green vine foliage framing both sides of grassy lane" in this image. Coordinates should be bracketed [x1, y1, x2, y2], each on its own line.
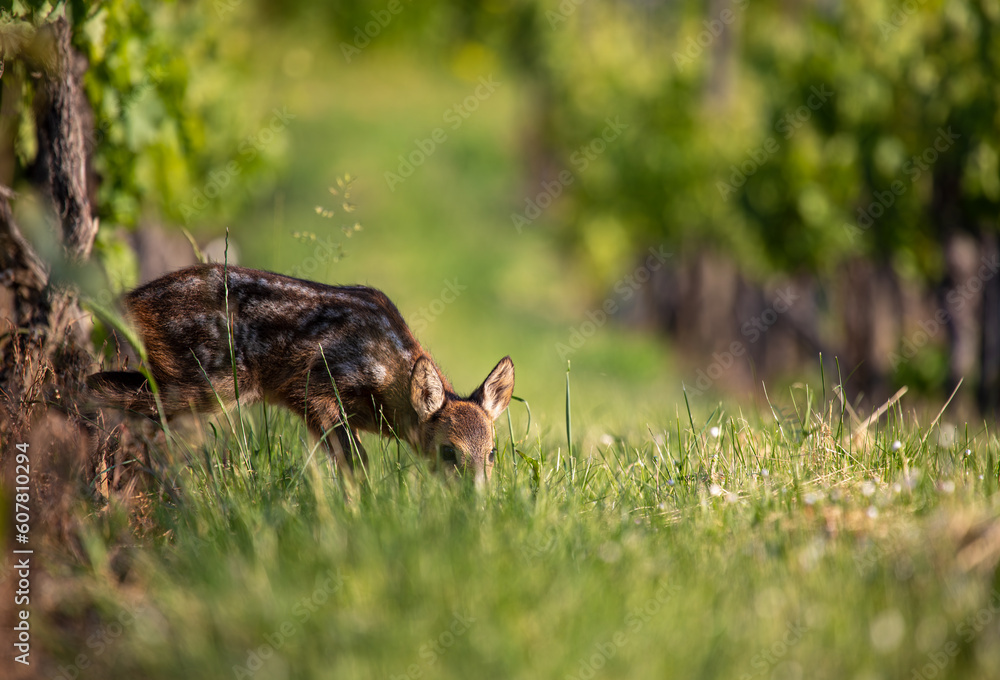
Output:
[13, 0, 1000, 288]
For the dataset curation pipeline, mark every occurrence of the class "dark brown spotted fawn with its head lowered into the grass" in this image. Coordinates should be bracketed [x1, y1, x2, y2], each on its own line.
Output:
[87, 264, 514, 484]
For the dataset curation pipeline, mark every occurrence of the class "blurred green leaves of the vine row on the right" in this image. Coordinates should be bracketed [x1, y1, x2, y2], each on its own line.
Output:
[256, 0, 1000, 280]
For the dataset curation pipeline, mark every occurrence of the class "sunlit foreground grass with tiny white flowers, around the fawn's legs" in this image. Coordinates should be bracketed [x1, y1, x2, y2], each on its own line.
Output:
[45, 382, 1000, 680]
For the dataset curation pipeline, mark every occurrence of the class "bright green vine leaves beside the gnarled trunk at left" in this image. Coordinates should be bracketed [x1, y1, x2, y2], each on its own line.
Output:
[4, 0, 281, 226]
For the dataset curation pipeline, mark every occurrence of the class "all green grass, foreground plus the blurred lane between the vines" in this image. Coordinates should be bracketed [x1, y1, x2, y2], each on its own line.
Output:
[50, 26, 1000, 680]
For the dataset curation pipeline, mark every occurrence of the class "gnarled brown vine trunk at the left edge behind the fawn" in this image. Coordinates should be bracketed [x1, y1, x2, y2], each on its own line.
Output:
[0, 18, 97, 440]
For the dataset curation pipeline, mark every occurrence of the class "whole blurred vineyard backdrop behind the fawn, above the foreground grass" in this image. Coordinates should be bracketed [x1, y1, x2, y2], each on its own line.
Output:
[0, 0, 1000, 436]
